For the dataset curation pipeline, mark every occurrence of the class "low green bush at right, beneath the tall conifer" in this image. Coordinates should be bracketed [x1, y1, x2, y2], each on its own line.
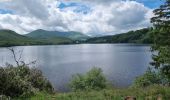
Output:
[132, 68, 164, 87]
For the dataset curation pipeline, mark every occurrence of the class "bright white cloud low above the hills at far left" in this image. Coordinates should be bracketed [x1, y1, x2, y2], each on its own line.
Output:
[0, 14, 41, 34]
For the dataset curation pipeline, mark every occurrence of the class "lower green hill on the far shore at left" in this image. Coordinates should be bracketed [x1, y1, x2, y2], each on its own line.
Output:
[0, 30, 73, 46]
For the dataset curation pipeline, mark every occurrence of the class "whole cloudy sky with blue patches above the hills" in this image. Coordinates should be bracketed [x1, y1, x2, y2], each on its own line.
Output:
[0, 0, 162, 35]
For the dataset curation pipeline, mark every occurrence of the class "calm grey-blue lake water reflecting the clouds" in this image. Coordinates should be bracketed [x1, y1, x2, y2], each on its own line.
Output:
[0, 44, 151, 91]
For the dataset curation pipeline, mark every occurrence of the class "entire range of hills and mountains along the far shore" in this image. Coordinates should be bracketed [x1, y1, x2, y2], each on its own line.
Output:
[0, 28, 153, 46]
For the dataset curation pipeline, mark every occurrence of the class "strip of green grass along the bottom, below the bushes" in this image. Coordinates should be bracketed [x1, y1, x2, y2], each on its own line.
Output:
[17, 85, 170, 100]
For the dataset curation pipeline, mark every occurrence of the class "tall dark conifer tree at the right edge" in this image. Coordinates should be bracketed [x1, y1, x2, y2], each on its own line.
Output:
[151, 0, 170, 80]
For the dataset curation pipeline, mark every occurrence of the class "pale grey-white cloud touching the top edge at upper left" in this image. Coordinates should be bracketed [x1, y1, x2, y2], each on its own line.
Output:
[0, 0, 49, 19]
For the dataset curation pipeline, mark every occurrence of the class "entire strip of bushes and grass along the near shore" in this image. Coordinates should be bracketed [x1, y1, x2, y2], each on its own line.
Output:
[0, 66, 170, 100]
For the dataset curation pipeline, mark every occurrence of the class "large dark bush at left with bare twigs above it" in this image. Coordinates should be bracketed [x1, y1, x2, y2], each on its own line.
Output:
[0, 65, 53, 97]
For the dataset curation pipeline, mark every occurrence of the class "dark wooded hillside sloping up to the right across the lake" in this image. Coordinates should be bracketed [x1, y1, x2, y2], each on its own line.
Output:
[86, 28, 153, 44]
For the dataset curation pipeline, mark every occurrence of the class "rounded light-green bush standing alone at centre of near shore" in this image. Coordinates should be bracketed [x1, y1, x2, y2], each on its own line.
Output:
[70, 68, 107, 91]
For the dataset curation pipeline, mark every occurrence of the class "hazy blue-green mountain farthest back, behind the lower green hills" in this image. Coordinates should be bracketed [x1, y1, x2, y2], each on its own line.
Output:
[25, 29, 89, 40]
